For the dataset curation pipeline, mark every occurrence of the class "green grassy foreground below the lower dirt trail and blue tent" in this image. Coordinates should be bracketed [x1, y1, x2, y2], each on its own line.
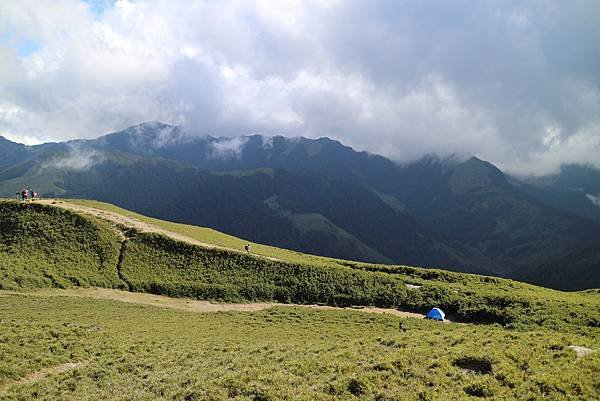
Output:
[0, 292, 600, 401]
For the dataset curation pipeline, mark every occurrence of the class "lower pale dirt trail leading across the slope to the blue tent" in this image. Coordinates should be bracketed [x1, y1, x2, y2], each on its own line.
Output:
[0, 288, 432, 319]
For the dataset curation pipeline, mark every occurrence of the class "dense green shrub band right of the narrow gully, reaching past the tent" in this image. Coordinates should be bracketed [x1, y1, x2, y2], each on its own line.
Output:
[122, 234, 600, 330]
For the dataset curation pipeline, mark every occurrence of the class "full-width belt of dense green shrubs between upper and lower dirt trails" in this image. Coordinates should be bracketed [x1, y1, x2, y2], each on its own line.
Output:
[0, 198, 600, 336]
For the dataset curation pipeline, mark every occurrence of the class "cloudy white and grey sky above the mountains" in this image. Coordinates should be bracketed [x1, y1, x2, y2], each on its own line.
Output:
[0, 0, 600, 175]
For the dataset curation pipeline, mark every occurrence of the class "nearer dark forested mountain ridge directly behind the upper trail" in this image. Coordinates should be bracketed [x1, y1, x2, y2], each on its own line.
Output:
[56, 161, 460, 265]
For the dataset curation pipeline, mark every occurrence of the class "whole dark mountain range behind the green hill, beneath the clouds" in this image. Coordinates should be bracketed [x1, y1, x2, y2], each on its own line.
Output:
[0, 122, 600, 290]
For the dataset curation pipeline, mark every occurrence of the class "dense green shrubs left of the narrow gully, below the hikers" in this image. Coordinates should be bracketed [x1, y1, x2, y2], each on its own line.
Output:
[0, 202, 124, 289]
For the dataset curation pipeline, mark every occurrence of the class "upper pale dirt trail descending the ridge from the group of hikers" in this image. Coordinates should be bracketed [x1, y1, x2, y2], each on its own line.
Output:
[36, 199, 280, 261]
